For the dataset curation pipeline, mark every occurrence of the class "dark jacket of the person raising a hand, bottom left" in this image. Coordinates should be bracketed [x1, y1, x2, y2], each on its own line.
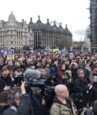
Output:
[3, 94, 31, 115]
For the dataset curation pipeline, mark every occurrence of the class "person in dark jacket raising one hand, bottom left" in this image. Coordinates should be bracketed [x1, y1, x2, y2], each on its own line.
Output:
[3, 83, 31, 115]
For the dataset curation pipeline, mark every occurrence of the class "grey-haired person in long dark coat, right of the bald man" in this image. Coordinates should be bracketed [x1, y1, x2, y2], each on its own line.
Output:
[74, 69, 89, 109]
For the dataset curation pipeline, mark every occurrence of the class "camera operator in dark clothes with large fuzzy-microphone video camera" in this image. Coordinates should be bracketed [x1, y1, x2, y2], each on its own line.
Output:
[24, 68, 48, 115]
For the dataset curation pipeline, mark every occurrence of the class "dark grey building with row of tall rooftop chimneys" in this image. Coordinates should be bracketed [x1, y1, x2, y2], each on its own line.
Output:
[29, 16, 72, 48]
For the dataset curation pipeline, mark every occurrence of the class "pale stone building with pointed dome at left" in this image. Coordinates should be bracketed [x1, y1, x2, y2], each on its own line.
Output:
[0, 12, 34, 49]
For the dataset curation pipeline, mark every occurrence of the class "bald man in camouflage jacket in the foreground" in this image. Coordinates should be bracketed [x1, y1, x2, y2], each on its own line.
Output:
[50, 85, 77, 115]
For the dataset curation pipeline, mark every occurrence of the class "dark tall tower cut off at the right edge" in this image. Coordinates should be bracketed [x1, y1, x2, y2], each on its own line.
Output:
[90, 0, 97, 50]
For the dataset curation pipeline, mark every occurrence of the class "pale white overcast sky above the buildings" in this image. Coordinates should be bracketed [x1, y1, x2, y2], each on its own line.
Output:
[0, 0, 89, 41]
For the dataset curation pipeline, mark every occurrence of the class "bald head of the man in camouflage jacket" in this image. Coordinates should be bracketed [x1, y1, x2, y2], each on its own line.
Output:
[55, 84, 69, 97]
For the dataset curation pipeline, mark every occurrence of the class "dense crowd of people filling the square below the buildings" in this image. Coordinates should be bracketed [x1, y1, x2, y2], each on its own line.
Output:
[0, 50, 97, 115]
